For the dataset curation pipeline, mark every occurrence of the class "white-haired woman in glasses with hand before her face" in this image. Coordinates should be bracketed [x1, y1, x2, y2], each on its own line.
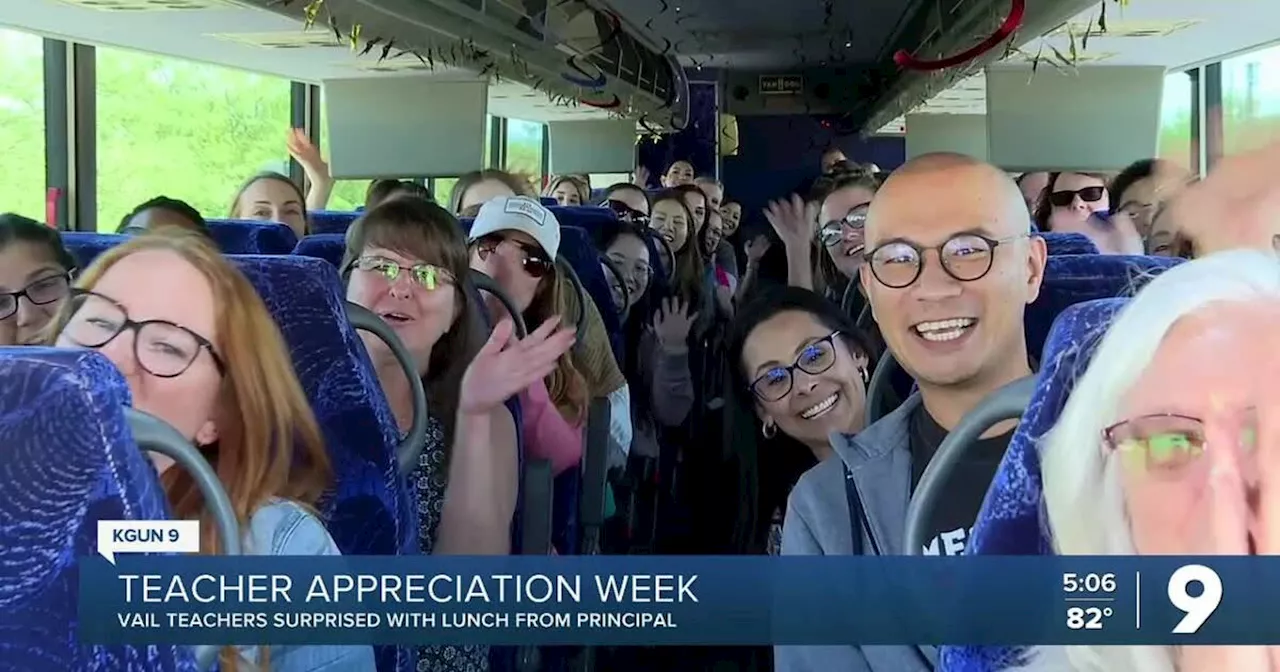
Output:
[1021, 250, 1280, 672]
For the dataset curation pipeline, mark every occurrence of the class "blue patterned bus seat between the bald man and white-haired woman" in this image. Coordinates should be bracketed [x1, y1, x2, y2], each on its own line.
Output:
[940, 298, 1128, 672]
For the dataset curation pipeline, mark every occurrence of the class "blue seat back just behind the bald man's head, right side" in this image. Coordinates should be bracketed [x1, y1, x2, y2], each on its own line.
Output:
[1025, 255, 1183, 361]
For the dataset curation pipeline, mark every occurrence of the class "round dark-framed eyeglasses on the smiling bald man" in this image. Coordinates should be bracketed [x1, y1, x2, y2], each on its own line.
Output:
[865, 233, 1029, 289]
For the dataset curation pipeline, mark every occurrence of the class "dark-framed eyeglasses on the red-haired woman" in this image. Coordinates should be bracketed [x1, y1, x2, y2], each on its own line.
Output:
[60, 289, 227, 378]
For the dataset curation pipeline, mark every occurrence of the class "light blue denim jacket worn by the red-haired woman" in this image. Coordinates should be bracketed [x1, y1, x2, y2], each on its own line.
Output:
[239, 499, 376, 672]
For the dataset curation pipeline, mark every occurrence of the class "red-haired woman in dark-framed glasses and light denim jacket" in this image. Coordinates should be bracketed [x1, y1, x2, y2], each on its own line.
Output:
[54, 232, 374, 672]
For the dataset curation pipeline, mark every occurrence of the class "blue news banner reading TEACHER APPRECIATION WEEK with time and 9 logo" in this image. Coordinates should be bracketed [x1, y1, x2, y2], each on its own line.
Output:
[79, 556, 1280, 645]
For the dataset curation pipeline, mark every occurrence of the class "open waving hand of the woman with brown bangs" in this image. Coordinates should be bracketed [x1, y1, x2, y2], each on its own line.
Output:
[458, 316, 577, 415]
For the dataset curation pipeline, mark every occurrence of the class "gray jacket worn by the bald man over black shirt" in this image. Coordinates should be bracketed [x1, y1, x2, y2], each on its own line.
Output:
[773, 394, 937, 672]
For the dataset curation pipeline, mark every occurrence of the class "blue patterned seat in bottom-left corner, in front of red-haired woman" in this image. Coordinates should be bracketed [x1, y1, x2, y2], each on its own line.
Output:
[0, 347, 198, 672]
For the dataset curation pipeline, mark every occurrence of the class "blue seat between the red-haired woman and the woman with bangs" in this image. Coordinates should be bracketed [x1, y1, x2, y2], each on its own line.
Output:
[232, 255, 419, 672]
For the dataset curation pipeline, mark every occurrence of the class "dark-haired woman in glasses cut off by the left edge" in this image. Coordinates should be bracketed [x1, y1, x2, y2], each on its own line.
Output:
[0, 214, 76, 346]
